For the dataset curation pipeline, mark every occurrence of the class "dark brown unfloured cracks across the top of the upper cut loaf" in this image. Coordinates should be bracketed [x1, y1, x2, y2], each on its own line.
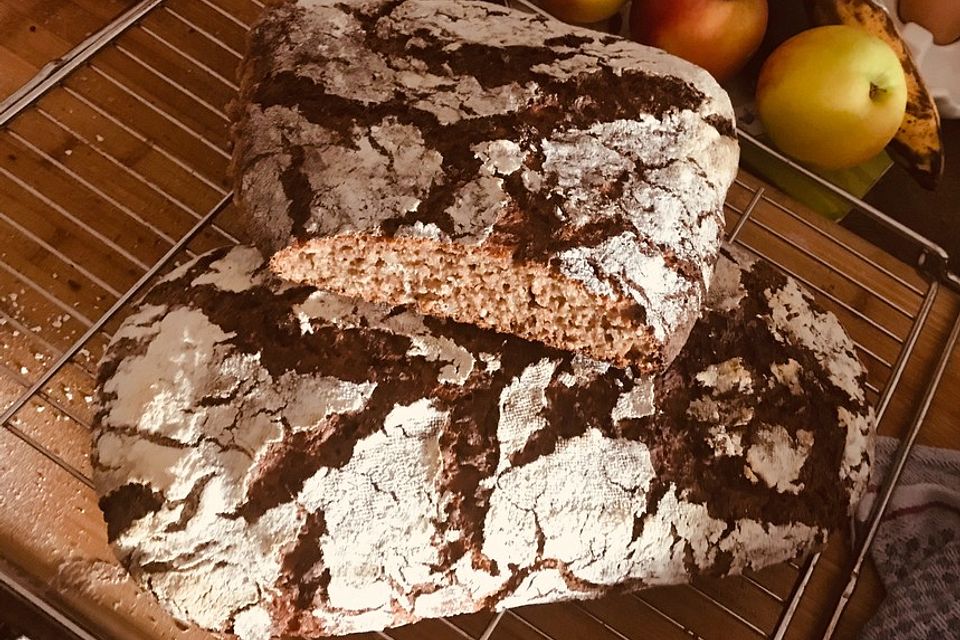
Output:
[231, 0, 736, 261]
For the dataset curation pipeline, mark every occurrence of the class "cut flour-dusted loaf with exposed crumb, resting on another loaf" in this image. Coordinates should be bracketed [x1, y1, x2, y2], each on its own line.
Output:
[231, 0, 739, 371]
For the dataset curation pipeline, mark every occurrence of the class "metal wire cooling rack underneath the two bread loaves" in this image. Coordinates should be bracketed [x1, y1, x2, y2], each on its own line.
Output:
[0, 0, 960, 640]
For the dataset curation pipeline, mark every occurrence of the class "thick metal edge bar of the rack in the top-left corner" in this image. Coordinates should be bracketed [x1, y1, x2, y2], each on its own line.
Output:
[0, 0, 163, 128]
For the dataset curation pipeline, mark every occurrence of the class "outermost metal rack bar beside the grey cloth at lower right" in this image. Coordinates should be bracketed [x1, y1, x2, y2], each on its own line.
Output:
[823, 314, 960, 640]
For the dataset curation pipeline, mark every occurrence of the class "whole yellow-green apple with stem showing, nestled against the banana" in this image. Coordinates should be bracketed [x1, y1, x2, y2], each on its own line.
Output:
[757, 25, 907, 169]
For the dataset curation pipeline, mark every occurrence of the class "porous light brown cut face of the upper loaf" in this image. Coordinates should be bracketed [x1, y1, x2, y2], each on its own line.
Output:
[271, 235, 663, 371]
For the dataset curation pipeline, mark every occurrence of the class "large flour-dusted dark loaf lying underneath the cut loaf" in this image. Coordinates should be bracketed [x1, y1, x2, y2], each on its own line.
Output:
[93, 247, 874, 640]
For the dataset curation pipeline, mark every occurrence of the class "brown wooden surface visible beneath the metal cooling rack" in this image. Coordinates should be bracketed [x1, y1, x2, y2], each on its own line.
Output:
[0, 0, 960, 640]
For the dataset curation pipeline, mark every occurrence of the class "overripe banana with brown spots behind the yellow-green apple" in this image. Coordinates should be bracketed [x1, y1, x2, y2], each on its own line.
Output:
[807, 0, 943, 190]
